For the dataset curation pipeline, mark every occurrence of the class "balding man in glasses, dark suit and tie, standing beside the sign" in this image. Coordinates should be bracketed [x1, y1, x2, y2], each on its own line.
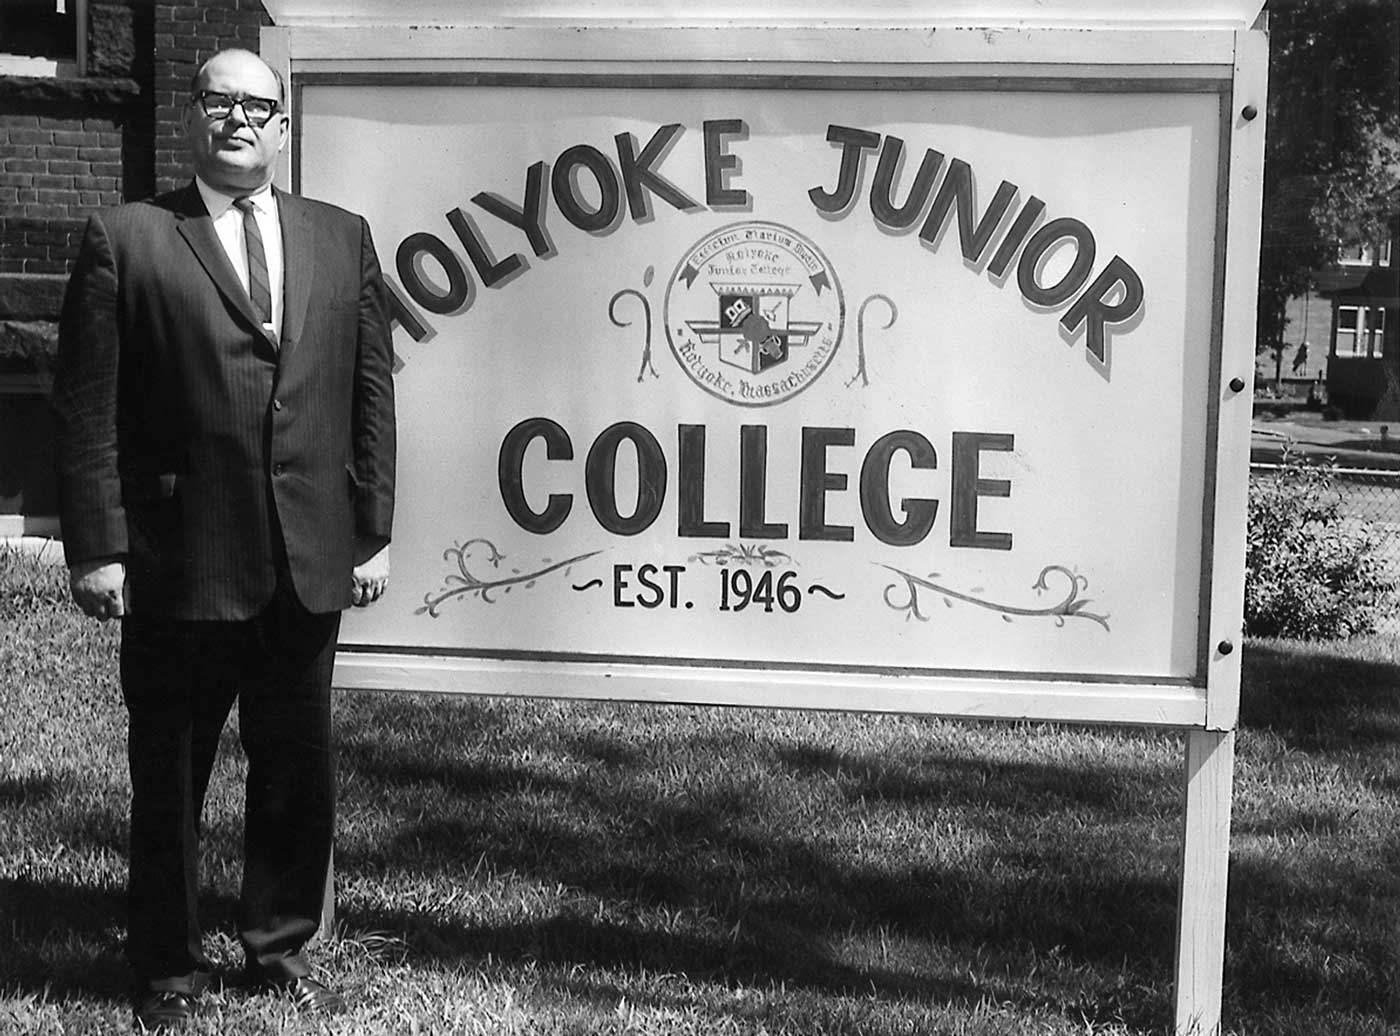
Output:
[53, 50, 395, 1028]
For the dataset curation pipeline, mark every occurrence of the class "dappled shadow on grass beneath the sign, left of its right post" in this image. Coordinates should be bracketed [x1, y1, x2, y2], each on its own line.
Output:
[327, 707, 1179, 1025]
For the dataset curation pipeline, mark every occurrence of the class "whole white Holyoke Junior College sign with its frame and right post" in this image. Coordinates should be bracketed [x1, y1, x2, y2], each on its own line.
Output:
[263, 0, 1267, 1033]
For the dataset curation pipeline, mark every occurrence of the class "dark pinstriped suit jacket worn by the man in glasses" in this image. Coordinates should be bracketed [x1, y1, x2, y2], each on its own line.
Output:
[53, 183, 395, 620]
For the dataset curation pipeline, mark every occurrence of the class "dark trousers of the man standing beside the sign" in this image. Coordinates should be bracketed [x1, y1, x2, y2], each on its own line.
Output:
[120, 578, 340, 991]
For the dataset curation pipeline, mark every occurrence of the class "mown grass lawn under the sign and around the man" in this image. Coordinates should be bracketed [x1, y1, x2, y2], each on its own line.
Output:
[0, 552, 1400, 1036]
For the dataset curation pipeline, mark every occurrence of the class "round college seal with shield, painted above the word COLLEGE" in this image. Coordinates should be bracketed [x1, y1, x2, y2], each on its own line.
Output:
[664, 221, 846, 406]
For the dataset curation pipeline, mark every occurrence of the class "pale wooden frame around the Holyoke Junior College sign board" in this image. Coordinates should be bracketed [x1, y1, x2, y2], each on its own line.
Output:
[263, 25, 1261, 729]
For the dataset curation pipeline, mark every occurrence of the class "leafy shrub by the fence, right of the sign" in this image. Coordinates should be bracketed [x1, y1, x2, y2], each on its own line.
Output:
[1245, 447, 1394, 640]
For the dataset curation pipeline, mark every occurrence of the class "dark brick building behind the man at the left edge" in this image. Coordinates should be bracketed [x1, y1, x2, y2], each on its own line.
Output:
[0, 0, 270, 536]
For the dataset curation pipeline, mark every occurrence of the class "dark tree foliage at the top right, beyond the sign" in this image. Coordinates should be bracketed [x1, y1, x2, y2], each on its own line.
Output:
[1259, 0, 1400, 349]
